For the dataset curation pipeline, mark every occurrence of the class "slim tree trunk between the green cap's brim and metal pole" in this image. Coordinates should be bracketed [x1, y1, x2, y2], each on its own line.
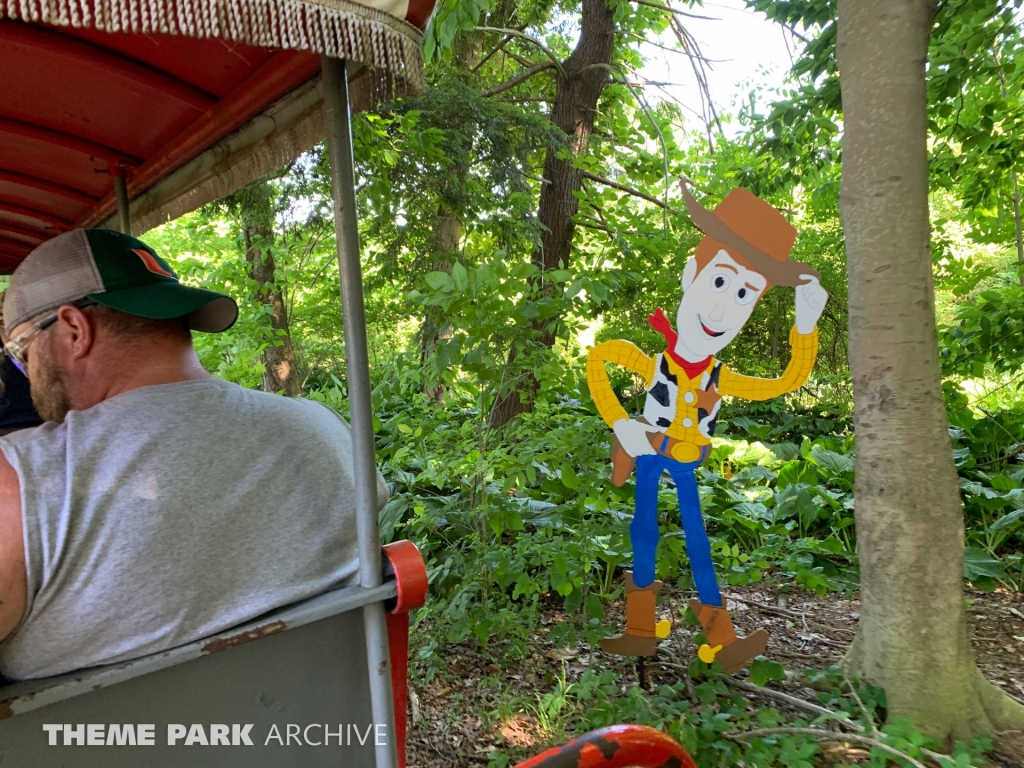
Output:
[239, 179, 302, 397]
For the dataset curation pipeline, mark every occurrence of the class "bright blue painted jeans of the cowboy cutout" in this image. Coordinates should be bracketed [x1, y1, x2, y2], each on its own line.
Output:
[630, 454, 722, 605]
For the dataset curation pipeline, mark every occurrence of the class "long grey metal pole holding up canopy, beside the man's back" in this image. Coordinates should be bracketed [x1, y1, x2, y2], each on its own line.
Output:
[321, 56, 397, 768]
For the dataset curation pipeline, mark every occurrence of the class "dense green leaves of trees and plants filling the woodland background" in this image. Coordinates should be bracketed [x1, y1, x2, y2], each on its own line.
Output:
[150, 0, 1024, 765]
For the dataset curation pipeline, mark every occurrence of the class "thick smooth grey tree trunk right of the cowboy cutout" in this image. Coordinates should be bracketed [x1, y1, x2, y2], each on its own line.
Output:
[838, 0, 1024, 741]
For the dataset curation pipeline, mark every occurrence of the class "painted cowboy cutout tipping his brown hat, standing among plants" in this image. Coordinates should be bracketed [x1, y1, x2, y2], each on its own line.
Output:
[587, 185, 828, 672]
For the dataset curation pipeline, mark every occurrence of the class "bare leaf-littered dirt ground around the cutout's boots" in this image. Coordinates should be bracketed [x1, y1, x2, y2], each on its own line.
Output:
[409, 586, 1024, 768]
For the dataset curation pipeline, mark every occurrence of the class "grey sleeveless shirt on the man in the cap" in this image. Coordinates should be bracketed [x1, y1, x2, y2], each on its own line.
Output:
[0, 380, 387, 679]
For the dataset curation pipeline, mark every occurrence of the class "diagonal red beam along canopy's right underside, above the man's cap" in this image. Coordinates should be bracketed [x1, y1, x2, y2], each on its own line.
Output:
[76, 51, 319, 226]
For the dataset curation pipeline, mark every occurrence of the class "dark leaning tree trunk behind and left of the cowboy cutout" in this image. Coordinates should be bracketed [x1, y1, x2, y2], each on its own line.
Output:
[490, 0, 615, 427]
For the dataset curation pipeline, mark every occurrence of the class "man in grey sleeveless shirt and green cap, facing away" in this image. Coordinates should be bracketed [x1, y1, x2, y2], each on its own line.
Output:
[0, 229, 387, 679]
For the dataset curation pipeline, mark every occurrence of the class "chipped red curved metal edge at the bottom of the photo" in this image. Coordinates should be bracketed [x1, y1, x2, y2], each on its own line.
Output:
[516, 725, 697, 768]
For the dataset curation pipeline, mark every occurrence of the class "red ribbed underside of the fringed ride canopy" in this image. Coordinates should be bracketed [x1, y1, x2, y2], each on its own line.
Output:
[0, 19, 319, 271]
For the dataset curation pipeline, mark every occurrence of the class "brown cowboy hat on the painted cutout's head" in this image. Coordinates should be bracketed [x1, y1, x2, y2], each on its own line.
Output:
[679, 179, 820, 286]
